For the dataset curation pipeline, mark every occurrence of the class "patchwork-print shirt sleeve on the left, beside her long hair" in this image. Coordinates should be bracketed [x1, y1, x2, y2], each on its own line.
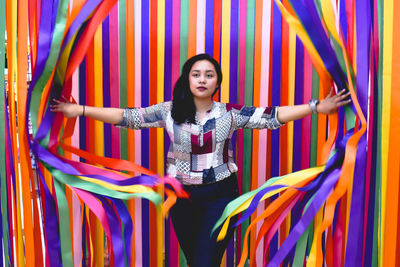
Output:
[115, 102, 170, 130]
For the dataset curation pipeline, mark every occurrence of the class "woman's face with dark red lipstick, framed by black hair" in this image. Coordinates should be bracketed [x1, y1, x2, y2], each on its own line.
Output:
[189, 59, 219, 100]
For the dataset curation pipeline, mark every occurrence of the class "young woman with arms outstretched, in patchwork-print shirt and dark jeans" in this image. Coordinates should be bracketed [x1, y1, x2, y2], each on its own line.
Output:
[51, 54, 350, 267]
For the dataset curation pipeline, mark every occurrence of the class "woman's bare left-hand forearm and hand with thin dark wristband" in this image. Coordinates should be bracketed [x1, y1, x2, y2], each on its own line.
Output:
[50, 99, 124, 124]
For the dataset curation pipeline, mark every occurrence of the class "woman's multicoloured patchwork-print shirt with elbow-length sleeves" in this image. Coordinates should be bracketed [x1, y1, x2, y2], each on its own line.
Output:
[117, 101, 282, 184]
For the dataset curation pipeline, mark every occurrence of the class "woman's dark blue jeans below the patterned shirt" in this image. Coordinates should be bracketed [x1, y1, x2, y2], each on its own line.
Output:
[170, 174, 239, 267]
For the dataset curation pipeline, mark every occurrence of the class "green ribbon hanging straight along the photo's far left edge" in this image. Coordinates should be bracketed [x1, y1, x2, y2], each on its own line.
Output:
[0, 0, 10, 265]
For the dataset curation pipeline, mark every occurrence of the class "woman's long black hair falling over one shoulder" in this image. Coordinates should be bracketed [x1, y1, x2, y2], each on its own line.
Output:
[171, 54, 222, 124]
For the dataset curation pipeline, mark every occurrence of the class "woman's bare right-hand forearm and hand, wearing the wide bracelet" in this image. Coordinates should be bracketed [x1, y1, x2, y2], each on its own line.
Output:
[278, 89, 351, 123]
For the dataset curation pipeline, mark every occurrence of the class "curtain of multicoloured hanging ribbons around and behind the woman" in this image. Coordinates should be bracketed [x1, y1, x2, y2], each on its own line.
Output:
[0, 0, 400, 266]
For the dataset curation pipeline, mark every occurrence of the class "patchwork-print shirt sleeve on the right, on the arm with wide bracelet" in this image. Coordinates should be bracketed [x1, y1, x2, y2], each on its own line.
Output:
[231, 105, 283, 130]
